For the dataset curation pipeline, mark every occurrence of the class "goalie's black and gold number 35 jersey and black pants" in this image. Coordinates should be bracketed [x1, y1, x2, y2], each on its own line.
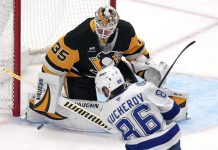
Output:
[42, 18, 149, 100]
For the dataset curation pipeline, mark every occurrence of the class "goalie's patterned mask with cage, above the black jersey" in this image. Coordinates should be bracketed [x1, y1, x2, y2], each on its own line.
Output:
[94, 6, 119, 40]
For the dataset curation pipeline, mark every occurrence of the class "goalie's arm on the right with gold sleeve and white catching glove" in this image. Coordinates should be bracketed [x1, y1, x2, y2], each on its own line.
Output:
[123, 23, 169, 85]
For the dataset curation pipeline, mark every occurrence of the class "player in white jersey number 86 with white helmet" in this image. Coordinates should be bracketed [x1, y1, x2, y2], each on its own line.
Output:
[95, 67, 182, 150]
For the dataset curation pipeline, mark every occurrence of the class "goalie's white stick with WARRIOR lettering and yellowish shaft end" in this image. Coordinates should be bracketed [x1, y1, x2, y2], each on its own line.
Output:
[0, 66, 113, 133]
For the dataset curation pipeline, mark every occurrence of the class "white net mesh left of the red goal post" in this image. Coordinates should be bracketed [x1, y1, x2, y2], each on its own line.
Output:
[0, 0, 14, 113]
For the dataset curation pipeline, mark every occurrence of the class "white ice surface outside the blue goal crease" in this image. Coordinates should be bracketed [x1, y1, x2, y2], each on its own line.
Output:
[0, 0, 218, 150]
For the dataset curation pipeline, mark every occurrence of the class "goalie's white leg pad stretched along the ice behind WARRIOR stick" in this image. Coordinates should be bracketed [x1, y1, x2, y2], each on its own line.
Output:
[27, 97, 115, 133]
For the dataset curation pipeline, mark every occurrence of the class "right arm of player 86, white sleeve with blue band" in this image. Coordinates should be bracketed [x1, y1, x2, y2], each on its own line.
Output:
[144, 82, 187, 121]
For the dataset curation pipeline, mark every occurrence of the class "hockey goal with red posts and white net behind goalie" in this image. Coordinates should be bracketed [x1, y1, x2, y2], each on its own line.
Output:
[0, 0, 116, 117]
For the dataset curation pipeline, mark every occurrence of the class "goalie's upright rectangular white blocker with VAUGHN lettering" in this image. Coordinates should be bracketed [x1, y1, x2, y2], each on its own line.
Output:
[33, 72, 63, 113]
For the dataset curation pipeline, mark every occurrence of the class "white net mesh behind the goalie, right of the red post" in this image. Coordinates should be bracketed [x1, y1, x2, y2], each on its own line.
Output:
[22, 0, 109, 51]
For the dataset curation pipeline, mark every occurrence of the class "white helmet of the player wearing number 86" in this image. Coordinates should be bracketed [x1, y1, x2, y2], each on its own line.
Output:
[95, 66, 125, 97]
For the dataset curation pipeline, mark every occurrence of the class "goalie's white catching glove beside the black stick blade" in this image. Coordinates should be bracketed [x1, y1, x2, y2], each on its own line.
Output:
[130, 55, 169, 86]
